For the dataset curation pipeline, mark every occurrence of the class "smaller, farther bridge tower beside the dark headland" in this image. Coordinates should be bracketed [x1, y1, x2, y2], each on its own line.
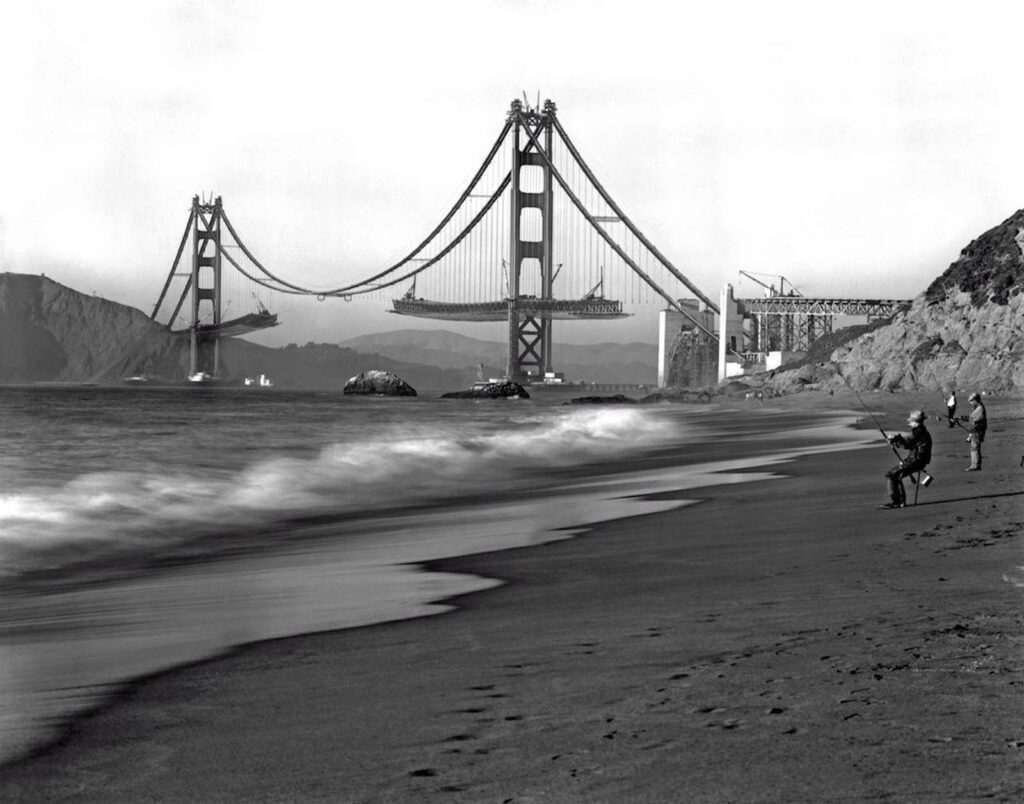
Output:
[188, 196, 223, 377]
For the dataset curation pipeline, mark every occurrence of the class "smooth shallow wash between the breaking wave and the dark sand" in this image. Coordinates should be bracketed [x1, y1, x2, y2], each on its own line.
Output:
[0, 414, 861, 763]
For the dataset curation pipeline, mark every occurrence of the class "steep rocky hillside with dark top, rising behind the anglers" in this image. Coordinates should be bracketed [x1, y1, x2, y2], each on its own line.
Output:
[770, 210, 1024, 393]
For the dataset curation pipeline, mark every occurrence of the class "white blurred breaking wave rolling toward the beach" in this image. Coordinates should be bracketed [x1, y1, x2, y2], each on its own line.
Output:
[0, 409, 678, 576]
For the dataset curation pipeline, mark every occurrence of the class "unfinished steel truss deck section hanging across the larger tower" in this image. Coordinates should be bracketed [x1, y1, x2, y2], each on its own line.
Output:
[391, 297, 630, 321]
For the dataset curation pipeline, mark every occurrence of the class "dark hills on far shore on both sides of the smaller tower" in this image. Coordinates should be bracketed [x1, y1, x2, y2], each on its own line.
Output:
[0, 273, 475, 390]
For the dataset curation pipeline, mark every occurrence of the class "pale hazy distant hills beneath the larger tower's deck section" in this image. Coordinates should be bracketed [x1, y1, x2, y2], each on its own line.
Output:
[338, 330, 657, 384]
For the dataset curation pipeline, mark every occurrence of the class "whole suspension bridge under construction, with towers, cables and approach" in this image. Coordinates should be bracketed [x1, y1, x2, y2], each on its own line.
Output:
[151, 100, 906, 382]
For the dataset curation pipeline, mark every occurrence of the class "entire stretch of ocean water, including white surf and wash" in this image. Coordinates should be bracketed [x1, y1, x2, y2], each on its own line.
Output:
[0, 387, 863, 761]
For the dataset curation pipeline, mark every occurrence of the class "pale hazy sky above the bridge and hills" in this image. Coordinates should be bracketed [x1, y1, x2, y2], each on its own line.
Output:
[0, 0, 1024, 343]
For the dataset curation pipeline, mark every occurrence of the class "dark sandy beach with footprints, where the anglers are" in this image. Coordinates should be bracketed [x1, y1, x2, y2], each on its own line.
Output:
[0, 393, 1024, 802]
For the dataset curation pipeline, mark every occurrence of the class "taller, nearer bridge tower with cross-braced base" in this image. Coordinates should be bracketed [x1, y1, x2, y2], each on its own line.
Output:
[506, 100, 556, 382]
